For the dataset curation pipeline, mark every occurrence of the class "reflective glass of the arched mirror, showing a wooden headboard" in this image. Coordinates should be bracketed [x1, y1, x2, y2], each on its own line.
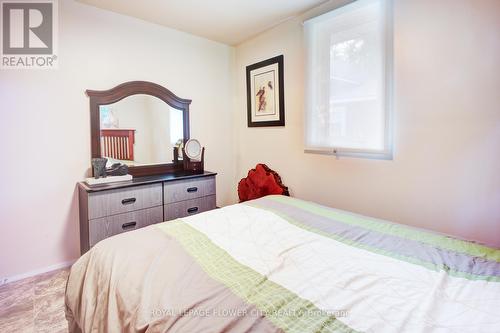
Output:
[99, 95, 184, 166]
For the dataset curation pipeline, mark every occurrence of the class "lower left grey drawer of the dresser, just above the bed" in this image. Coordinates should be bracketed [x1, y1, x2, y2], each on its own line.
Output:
[89, 206, 163, 247]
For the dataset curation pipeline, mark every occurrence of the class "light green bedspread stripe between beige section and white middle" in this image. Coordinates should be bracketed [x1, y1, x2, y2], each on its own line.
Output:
[157, 220, 355, 333]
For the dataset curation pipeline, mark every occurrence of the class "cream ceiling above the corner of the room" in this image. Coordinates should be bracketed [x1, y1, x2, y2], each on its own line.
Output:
[79, 0, 325, 45]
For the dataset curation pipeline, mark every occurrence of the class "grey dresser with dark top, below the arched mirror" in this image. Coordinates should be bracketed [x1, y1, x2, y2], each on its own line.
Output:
[78, 171, 216, 254]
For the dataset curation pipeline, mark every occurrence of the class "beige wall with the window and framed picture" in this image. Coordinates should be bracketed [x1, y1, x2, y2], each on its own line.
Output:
[236, 0, 500, 247]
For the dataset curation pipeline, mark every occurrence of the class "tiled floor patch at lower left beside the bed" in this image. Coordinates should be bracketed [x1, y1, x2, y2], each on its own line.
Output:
[0, 269, 69, 333]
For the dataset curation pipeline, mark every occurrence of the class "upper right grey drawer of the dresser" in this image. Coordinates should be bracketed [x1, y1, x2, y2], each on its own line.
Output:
[163, 177, 215, 204]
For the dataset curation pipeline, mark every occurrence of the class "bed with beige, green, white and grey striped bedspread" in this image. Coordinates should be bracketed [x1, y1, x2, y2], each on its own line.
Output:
[65, 195, 500, 333]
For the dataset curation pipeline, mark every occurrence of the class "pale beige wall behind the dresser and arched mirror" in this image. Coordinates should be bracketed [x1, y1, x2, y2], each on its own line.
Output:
[0, 0, 235, 283]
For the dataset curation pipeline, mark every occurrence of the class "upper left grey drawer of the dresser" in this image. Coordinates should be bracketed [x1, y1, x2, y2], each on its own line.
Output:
[88, 183, 163, 220]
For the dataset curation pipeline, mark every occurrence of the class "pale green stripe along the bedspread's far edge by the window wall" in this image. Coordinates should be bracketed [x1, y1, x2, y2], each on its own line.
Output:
[268, 195, 500, 262]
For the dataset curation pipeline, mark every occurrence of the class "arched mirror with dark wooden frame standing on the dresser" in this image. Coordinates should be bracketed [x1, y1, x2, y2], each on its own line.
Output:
[86, 81, 191, 176]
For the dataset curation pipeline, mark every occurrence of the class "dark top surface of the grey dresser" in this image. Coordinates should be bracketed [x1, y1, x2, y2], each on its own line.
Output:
[78, 170, 217, 193]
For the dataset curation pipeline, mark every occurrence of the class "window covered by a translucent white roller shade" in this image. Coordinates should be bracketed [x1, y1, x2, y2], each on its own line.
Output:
[304, 0, 392, 159]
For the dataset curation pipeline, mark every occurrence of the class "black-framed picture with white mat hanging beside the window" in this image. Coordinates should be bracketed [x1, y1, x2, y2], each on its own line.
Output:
[246, 55, 285, 127]
